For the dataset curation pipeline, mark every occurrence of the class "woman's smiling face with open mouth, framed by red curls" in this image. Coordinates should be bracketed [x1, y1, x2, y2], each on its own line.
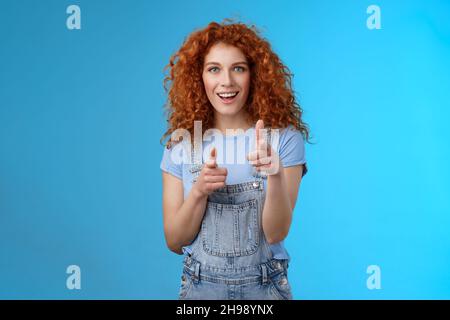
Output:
[203, 43, 250, 116]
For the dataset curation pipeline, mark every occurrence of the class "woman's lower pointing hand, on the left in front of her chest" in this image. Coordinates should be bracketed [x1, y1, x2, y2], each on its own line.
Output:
[192, 147, 228, 196]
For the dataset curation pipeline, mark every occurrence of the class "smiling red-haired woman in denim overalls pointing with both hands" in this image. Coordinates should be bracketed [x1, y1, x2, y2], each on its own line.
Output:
[161, 21, 309, 299]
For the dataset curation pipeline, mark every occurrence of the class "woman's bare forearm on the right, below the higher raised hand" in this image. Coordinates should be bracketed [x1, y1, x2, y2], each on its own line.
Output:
[262, 165, 292, 244]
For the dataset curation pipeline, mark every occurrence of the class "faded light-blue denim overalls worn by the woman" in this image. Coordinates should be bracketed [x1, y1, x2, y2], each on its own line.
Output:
[179, 130, 292, 300]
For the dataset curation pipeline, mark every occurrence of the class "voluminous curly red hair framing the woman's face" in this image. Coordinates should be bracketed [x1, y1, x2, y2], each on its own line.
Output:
[161, 20, 309, 146]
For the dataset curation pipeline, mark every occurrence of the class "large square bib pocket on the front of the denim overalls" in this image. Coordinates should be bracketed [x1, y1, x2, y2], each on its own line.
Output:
[201, 199, 260, 257]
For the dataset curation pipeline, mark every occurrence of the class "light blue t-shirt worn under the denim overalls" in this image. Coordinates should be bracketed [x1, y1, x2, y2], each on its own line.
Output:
[160, 126, 308, 259]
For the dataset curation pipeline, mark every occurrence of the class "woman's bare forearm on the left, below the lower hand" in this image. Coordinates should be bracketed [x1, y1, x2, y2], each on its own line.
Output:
[166, 187, 208, 253]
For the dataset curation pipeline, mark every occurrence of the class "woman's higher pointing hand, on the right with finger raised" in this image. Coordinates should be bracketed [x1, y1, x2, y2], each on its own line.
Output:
[247, 120, 281, 175]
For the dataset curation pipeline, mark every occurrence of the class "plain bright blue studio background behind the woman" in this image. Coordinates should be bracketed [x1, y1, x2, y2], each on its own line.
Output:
[0, 0, 450, 299]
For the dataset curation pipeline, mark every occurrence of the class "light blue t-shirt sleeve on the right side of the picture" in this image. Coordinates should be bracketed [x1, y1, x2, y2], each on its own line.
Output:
[279, 127, 308, 177]
